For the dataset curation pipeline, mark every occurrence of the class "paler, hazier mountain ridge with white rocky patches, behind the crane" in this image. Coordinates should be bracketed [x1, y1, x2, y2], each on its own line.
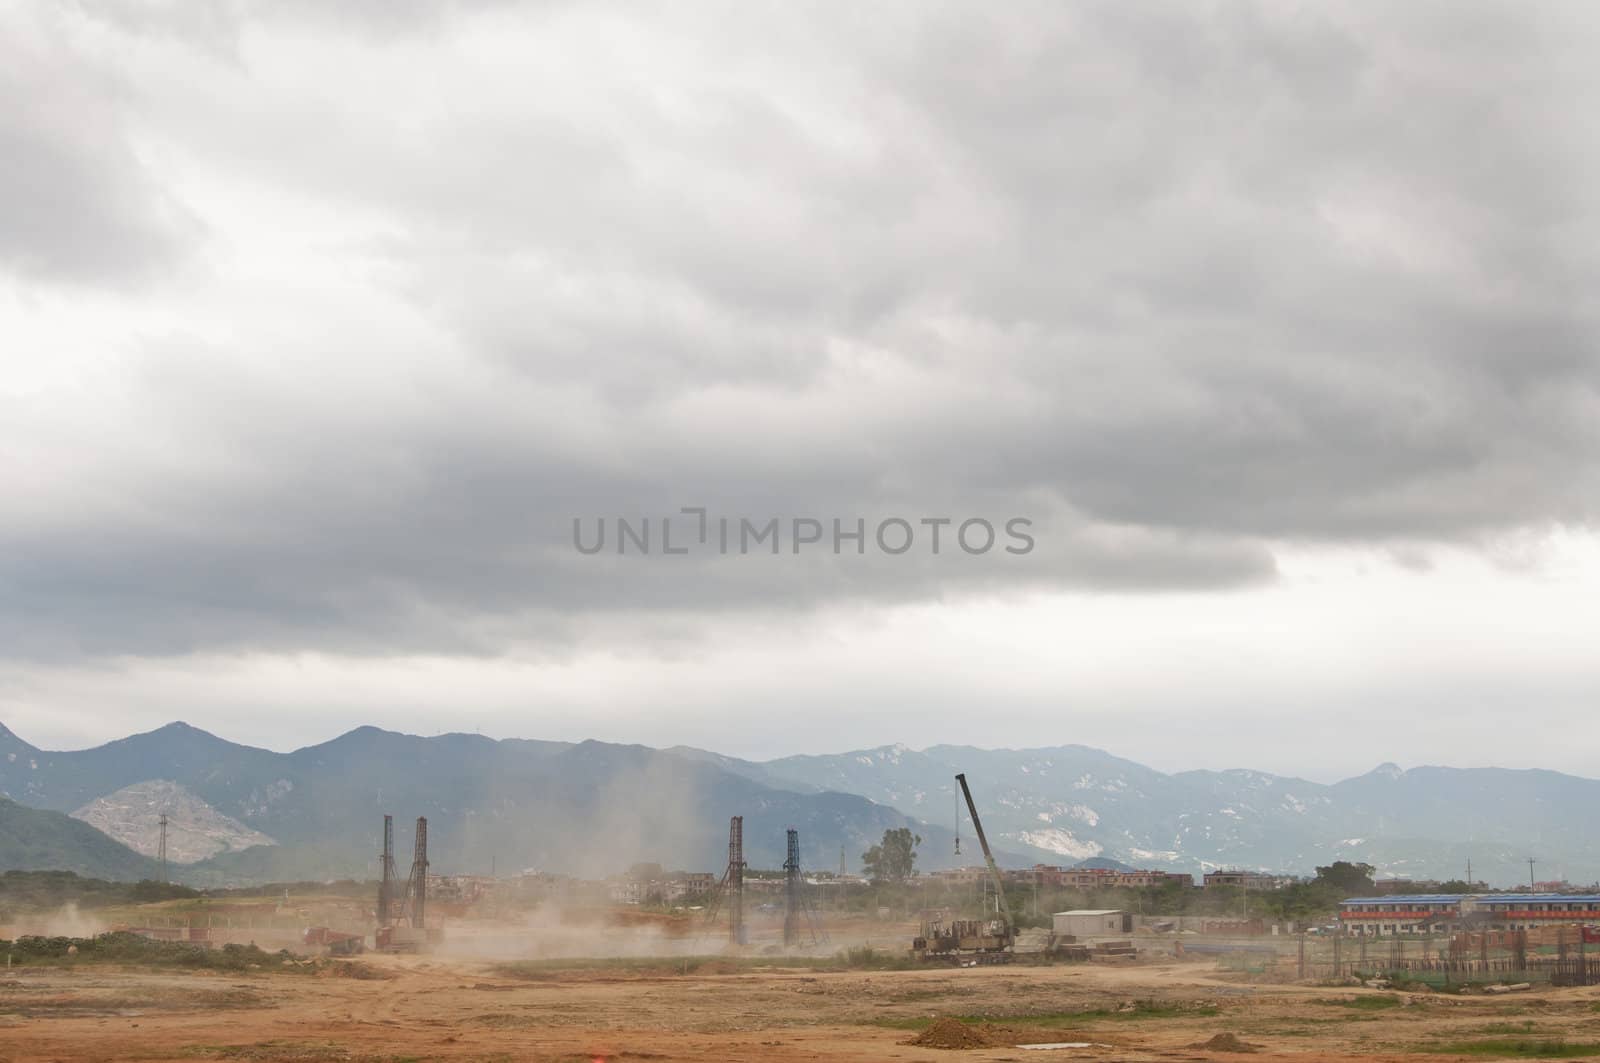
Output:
[700, 746, 1600, 885]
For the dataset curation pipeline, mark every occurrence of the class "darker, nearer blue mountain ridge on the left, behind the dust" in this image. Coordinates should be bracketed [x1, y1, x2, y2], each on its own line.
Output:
[0, 724, 972, 885]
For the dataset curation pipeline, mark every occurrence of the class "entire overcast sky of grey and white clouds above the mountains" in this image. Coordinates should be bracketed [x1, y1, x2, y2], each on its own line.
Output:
[0, 0, 1600, 780]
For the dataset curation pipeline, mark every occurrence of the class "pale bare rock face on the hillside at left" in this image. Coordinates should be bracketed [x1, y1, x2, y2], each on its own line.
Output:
[72, 780, 277, 863]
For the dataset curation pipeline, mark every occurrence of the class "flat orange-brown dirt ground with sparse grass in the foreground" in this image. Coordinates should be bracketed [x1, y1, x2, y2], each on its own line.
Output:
[0, 956, 1600, 1063]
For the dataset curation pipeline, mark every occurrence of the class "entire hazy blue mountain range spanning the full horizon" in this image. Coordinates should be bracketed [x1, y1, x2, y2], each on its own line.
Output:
[0, 724, 1600, 885]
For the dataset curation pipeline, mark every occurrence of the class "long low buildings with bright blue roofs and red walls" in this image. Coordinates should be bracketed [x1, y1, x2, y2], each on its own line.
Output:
[1339, 893, 1600, 935]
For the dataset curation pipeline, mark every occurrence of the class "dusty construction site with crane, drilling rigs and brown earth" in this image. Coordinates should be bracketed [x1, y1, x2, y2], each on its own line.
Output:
[9, 775, 1600, 1063]
